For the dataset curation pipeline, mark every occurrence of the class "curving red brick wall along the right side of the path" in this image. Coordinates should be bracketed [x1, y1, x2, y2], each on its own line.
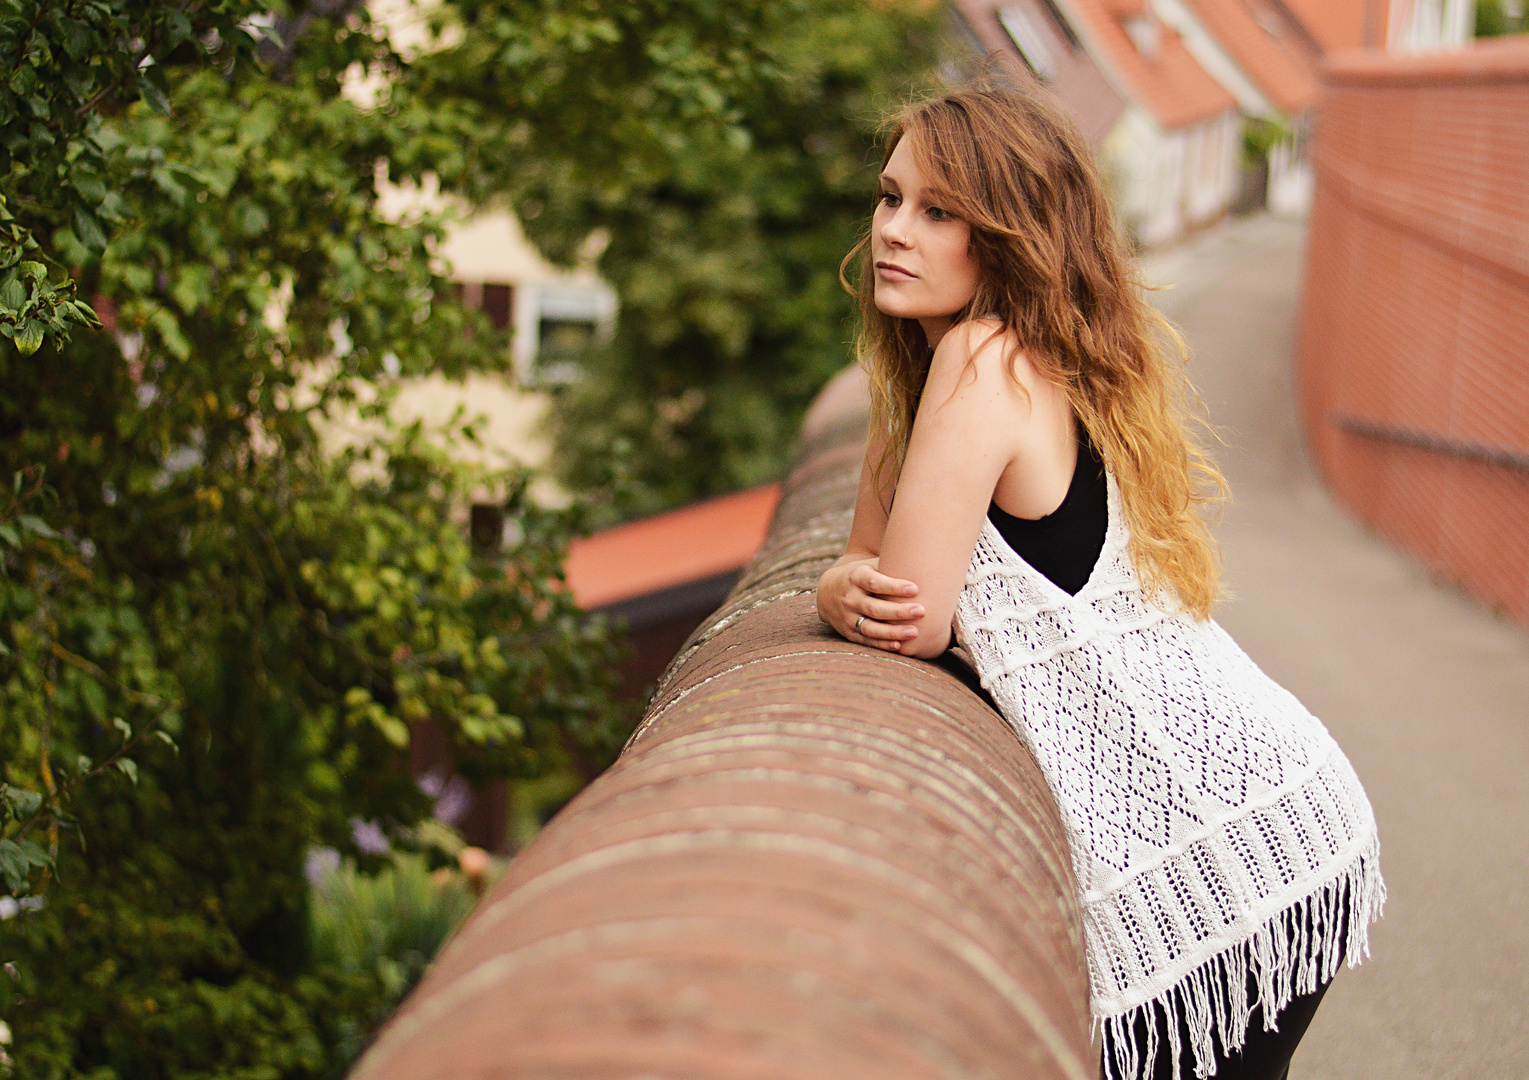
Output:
[1297, 38, 1529, 624]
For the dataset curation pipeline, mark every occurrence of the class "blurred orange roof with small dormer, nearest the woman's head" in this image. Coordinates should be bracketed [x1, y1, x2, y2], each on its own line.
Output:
[1060, 0, 1237, 130]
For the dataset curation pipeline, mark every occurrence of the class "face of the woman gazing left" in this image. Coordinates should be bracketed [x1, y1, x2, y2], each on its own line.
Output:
[870, 138, 977, 347]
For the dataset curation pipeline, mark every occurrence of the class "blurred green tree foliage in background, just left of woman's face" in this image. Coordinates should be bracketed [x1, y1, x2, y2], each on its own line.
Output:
[427, 0, 937, 512]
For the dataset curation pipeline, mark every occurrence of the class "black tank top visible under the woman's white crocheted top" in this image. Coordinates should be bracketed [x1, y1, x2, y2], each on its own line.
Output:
[988, 424, 1110, 595]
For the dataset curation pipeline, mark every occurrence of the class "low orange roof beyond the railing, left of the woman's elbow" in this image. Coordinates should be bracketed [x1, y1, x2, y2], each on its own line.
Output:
[566, 483, 780, 610]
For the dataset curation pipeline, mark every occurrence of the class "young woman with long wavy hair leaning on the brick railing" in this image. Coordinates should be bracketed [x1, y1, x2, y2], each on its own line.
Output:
[818, 87, 1385, 1078]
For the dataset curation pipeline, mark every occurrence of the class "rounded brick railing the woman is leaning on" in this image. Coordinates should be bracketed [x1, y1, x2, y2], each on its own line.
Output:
[355, 364, 1098, 1080]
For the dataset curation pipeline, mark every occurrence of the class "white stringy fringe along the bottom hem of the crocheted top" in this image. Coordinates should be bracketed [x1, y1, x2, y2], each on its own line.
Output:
[1095, 837, 1385, 1080]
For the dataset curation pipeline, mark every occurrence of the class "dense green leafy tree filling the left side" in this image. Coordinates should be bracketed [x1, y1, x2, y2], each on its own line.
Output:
[0, 0, 789, 1080]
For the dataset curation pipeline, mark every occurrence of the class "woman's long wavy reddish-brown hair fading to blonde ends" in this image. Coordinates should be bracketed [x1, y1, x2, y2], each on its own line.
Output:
[839, 80, 1226, 618]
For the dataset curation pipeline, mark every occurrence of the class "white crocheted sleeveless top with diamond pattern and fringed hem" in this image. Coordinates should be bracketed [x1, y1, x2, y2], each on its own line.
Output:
[956, 474, 1385, 1077]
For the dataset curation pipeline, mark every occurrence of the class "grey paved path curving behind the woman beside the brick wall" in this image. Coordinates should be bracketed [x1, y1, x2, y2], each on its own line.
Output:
[1145, 216, 1529, 1080]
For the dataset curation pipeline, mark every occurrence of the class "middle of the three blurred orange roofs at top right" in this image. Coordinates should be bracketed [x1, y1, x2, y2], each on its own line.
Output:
[1183, 0, 1321, 116]
